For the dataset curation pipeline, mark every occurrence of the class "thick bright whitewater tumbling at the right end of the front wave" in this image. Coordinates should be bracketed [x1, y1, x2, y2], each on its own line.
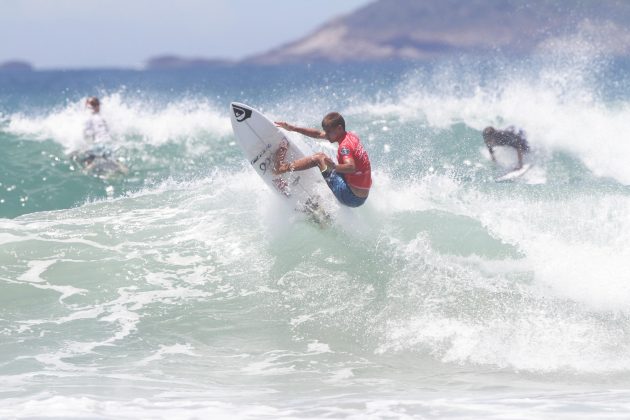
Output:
[478, 195, 630, 311]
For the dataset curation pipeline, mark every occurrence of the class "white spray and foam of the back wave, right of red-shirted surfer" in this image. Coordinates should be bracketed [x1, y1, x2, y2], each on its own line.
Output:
[347, 55, 630, 184]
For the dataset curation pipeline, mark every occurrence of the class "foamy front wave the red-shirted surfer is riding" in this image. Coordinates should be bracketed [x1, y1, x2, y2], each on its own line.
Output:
[0, 168, 630, 375]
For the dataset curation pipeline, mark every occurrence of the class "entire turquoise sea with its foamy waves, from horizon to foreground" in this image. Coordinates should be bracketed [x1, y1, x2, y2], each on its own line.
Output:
[0, 54, 630, 419]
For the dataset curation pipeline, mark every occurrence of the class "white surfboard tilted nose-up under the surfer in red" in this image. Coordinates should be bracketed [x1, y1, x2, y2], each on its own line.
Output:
[230, 102, 330, 224]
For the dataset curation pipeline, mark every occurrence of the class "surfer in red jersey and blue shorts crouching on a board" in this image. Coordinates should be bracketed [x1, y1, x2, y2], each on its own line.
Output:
[274, 112, 372, 207]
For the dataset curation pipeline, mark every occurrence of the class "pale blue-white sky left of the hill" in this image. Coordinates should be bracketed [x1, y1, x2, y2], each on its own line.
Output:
[0, 0, 373, 69]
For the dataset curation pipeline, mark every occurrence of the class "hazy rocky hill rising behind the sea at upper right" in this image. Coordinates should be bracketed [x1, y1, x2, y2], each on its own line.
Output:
[244, 0, 630, 64]
